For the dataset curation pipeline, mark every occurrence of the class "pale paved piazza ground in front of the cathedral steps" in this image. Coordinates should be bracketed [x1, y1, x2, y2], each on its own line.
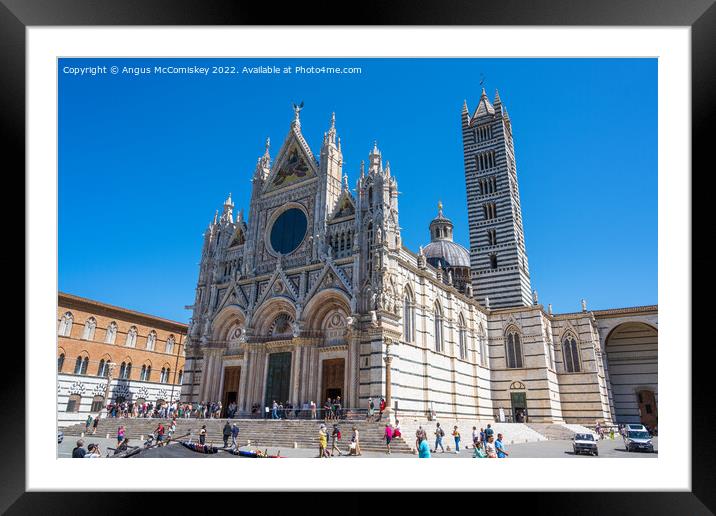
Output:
[58, 437, 659, 460]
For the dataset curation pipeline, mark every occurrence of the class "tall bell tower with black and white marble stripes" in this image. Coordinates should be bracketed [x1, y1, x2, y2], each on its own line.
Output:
[462, 88, 532, 308]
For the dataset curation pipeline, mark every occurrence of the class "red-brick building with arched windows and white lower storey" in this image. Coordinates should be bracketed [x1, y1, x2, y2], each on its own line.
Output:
[57, 292, 187, 426]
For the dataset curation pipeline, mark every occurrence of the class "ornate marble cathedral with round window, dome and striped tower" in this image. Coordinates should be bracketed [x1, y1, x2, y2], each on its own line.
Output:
[181, 90, 658, 426]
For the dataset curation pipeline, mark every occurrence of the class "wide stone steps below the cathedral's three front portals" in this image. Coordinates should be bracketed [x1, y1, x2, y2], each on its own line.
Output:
[63, 418, 414, 454]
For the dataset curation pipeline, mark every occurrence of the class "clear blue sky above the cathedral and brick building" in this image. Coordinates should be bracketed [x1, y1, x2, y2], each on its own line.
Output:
[58, 59, 657, 321]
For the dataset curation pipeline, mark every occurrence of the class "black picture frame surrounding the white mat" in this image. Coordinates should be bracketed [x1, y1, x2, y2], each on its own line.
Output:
[0, 0, 716, 515]
